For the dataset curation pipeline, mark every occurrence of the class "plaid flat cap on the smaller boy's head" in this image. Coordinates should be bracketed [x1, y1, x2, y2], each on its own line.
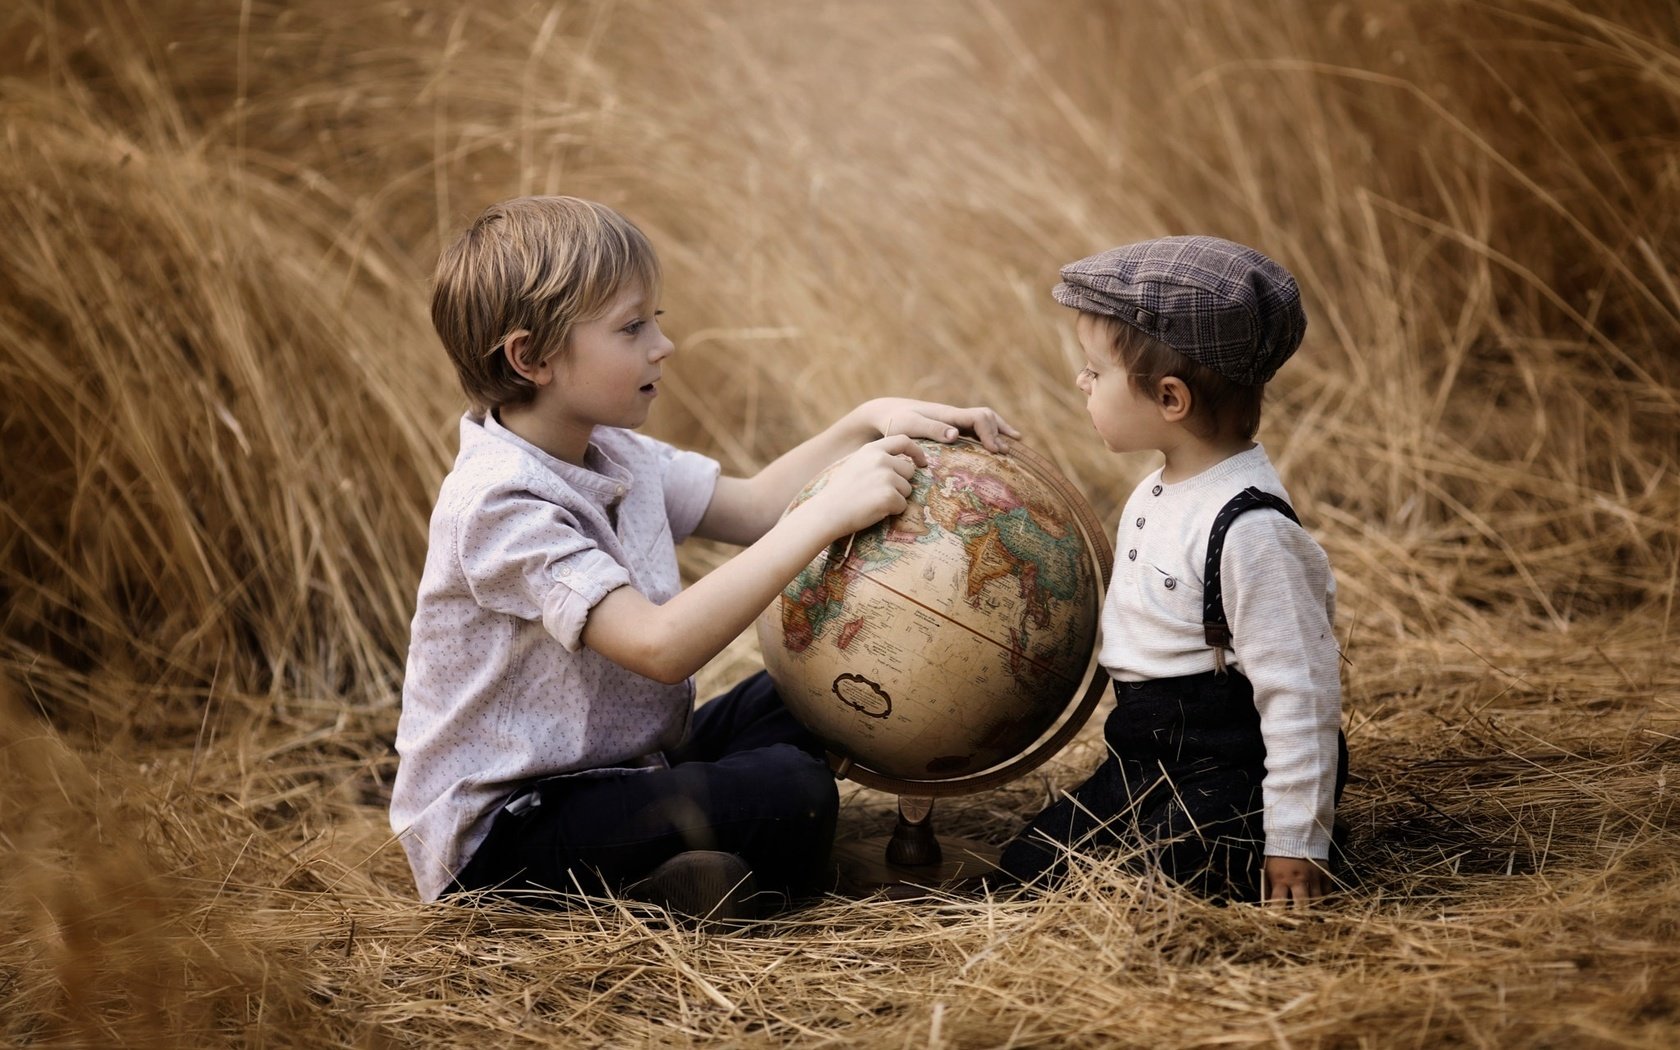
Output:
[1050, 237, 1307, 386]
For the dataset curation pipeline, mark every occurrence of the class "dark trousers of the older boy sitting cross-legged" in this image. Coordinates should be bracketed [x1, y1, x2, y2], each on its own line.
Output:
[455, 672, 840, 904]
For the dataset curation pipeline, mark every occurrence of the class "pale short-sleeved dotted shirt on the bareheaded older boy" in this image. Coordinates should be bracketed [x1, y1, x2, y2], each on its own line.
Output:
[391, 413, 719, 900]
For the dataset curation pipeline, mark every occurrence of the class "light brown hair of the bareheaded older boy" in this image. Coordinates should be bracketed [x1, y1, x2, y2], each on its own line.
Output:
[432, 197, 660, 410]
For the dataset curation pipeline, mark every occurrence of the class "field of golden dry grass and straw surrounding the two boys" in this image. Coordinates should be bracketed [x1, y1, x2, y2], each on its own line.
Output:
[0, 0, 1680, 1048]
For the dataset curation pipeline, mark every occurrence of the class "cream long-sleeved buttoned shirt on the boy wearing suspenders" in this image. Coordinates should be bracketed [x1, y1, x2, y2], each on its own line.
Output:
[1099, 445, 1342, 860]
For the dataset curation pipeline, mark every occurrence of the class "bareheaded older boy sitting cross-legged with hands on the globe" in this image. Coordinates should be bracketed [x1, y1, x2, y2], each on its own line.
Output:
[391, 197, 1016, 919]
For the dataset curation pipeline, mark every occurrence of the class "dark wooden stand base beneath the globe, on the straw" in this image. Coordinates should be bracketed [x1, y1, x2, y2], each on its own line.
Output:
[835, 795, 998, 900]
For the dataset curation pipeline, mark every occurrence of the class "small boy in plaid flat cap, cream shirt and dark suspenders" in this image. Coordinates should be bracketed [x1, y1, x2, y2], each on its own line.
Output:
[1001, 237, 1347, 904]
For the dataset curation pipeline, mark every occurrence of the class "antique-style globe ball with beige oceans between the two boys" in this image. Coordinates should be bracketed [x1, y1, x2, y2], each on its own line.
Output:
[758, 440, 1110, 795]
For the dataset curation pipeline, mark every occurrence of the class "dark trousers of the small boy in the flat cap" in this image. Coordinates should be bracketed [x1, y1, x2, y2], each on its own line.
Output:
[1000, 670, 1347, 900]
